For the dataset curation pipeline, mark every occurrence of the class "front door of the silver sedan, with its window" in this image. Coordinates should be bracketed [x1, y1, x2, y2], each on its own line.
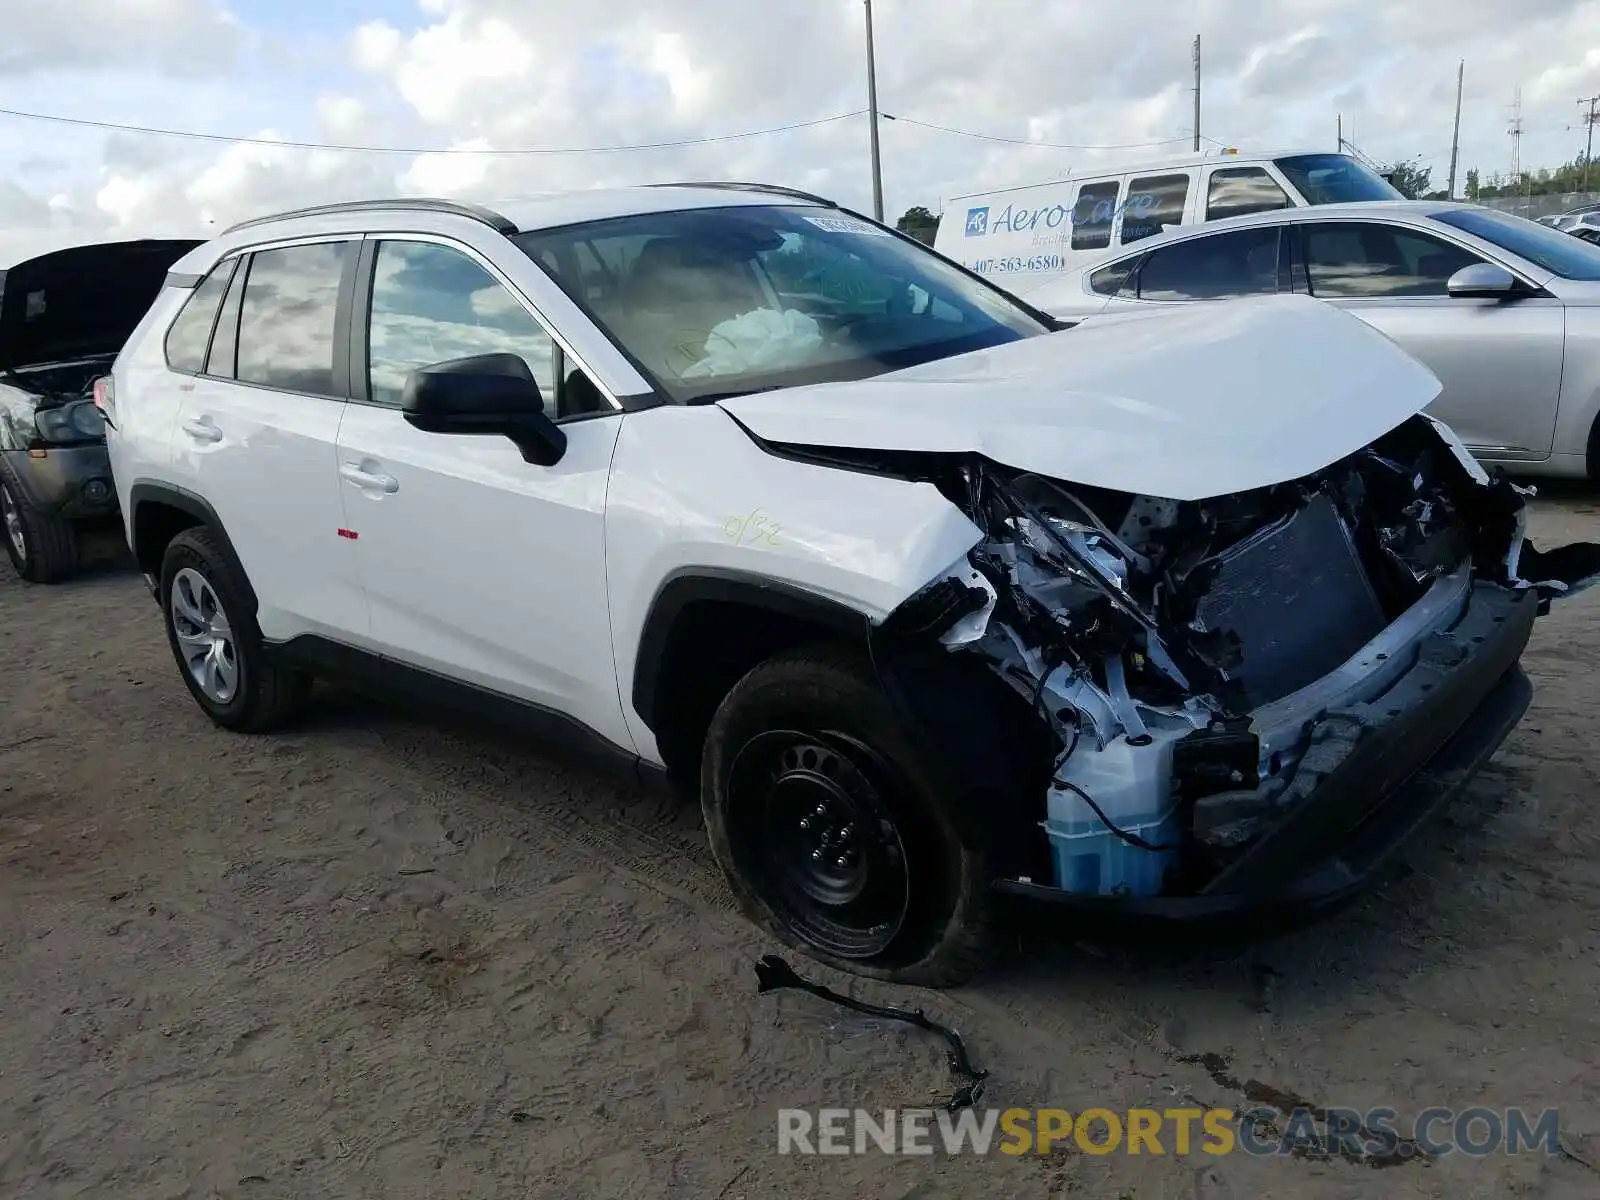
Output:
[1296, 221, 1565, 461]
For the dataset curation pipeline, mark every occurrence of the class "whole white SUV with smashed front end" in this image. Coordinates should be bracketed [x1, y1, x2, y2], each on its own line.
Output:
[98, 184, 1600, 984]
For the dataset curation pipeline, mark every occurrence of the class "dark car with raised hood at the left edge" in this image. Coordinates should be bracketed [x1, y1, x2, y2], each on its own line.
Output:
[0, 238, 200, 584]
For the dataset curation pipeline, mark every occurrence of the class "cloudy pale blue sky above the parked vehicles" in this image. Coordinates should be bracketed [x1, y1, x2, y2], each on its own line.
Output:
[0, 0, 1600, 259]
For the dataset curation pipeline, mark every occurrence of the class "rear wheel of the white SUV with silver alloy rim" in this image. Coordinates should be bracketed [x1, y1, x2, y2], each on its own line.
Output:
[160, 526, 310, 733]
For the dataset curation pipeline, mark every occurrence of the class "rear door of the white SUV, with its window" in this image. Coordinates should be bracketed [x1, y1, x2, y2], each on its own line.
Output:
[173, 238, 366, 640]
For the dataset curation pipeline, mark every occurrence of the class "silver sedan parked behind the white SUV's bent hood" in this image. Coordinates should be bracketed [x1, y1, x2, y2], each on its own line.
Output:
[1024, 200, 1600, 477]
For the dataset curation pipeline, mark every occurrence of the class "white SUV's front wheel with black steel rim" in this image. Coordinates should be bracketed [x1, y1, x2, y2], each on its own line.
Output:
[701, 648, 990, 987]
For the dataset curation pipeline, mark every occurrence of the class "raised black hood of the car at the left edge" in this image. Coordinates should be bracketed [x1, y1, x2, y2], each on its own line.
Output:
[0, 238, 200, 371]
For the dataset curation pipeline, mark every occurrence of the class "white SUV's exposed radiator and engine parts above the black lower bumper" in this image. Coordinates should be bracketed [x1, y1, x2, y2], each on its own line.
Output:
[812, 416, 1600, 896]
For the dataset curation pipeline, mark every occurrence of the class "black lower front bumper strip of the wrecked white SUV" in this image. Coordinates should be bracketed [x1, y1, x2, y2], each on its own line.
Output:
[997, 584, 1539, 920]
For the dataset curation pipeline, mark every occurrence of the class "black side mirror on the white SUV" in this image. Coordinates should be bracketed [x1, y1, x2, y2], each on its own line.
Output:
[400, 354, 566, 467]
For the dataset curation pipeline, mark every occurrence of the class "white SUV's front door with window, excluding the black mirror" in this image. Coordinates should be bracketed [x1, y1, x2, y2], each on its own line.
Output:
[338, 238, 632, 749]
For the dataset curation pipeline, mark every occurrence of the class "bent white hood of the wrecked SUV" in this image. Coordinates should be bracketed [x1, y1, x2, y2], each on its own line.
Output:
[718, 296, 1440, 501]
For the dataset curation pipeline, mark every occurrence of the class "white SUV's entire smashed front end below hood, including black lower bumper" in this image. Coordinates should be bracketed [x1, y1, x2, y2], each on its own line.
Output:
[864, 416, 1600, 912]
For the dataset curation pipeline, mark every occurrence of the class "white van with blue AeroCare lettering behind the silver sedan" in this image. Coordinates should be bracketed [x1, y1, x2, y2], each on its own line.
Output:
[933, 150, 1405, 293]
